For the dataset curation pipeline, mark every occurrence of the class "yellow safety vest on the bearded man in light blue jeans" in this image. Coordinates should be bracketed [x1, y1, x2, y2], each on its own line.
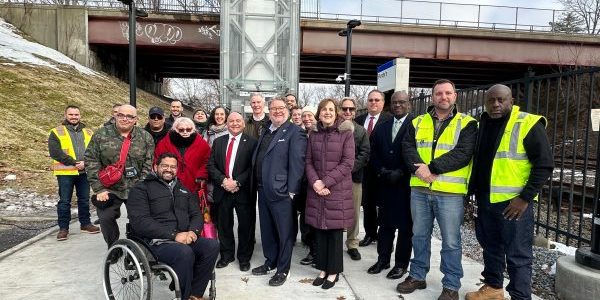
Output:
[410, 113, 477, 195]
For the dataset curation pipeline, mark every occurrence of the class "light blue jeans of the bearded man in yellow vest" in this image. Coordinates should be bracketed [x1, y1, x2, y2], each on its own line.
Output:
[410, 189, 464, 291]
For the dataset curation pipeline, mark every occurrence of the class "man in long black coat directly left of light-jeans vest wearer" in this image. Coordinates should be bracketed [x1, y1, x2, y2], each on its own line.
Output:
[368, 91, 413, 279]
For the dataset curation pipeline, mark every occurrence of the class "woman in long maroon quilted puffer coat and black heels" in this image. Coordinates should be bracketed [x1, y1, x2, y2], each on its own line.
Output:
[306, 99, 354, 289]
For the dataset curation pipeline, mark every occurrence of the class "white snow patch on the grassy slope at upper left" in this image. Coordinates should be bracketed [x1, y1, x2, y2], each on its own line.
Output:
[0, 18, 99, 75]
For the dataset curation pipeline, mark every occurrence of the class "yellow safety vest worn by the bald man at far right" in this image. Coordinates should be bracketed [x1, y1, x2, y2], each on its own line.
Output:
[490, 105, 547, 203]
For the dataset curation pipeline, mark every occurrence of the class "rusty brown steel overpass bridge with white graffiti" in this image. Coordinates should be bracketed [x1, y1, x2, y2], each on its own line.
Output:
[2, 7, 600, 87]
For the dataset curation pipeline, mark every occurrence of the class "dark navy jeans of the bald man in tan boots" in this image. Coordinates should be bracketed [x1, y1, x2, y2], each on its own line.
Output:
[475, 195, 534, 300]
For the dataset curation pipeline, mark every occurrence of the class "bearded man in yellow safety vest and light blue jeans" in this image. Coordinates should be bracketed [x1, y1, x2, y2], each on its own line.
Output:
[396, 79, 477, 300]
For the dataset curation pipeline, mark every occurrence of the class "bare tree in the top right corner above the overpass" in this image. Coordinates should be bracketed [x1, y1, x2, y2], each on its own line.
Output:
[558, 0, 600, 35]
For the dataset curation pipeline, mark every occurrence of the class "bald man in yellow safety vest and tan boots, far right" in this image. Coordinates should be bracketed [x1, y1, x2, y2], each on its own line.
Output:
[466, 84, 554, 300]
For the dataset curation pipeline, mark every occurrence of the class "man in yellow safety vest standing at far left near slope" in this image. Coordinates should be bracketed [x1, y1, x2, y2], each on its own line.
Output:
[48, 105, 100, 241]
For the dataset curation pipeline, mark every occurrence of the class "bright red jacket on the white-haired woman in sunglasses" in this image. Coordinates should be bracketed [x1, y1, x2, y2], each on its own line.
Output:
[154, 134, 210, 192]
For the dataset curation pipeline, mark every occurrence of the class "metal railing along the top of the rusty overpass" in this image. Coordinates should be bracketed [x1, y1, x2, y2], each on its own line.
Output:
[0, 0, 565, 32]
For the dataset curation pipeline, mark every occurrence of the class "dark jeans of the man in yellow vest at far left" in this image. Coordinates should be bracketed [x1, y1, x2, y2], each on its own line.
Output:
[56, 173, 92, 229]
